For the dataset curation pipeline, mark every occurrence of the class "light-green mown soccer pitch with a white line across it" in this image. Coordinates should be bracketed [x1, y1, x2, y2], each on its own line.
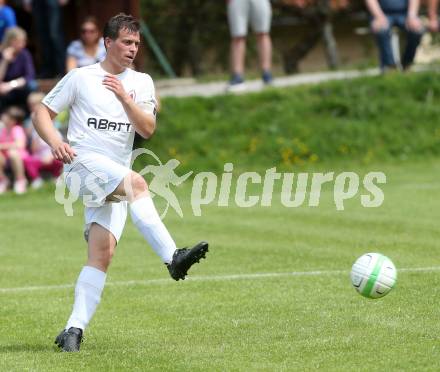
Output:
[0, 159, 440, 371]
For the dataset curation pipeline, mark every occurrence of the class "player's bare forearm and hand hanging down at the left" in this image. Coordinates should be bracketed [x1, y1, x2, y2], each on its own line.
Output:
[32, 103, 76, 164]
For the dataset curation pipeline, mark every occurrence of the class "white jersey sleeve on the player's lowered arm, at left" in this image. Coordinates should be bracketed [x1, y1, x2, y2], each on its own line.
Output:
[43, 69, 79, 114]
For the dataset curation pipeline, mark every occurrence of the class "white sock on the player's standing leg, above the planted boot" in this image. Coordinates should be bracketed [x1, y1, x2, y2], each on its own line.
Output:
[66, 266, 107, 330]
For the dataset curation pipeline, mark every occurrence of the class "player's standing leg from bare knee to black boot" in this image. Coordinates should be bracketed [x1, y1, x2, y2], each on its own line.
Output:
[55, 223, 116, 351]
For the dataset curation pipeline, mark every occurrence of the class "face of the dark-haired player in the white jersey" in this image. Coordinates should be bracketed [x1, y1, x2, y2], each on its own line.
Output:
[107, 29, 140, 67]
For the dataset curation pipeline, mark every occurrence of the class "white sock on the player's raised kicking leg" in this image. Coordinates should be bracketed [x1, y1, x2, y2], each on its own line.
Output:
[130, 196, 176, 264]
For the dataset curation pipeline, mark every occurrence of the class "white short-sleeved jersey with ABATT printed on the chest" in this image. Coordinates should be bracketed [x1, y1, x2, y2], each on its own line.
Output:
[43, 63, 157, 166]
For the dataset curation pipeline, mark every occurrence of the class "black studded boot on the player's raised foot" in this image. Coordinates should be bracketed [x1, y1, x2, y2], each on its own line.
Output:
[167, 242, 208, 280]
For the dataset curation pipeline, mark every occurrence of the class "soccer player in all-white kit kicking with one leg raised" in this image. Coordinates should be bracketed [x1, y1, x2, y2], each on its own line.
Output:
[33, 14, 208, 351]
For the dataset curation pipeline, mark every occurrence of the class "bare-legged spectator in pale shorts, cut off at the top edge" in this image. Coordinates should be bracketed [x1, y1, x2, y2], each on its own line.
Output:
[228, 0, 272, 87]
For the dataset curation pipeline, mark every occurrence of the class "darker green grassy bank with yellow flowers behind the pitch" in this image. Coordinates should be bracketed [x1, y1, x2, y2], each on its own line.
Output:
[138, 72, 440, 171]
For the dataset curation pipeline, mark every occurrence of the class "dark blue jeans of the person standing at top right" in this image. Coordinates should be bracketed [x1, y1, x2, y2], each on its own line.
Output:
[375, 13, 423, 68]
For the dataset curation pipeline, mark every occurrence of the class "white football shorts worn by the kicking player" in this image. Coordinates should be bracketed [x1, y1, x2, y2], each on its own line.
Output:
[64, 152, 131, 242]
